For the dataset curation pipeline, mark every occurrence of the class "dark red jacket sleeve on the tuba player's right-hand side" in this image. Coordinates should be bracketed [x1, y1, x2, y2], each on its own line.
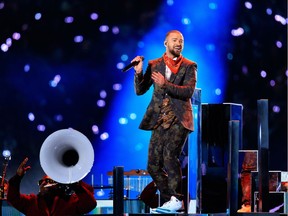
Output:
[75, 181, 97, 214]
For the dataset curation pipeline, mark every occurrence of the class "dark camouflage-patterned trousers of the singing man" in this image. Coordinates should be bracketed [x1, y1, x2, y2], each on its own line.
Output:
[147, 121, 189, 203]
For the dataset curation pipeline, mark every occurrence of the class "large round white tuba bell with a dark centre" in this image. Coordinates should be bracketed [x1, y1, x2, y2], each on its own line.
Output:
[40, 128, 94, 184]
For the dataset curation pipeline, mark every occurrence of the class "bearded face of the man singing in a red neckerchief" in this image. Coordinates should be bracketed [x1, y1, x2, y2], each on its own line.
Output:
[166, 32, 184, 57]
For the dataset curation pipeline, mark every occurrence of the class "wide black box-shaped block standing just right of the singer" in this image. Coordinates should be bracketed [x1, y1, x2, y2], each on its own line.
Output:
[200, 103, 243, 213]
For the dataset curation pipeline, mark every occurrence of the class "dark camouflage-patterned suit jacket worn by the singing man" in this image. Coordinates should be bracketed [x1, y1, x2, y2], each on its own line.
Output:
[134, 57, 197, 131]
